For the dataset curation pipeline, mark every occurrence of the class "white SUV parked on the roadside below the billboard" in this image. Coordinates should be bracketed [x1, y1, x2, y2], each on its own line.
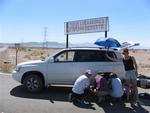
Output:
[12, 48, 125, 92]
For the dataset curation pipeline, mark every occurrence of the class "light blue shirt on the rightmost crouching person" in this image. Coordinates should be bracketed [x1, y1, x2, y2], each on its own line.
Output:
[110, 78, 123, 98]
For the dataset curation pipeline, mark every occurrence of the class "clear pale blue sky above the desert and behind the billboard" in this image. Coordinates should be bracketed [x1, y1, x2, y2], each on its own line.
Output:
[0, 0, 150, 47]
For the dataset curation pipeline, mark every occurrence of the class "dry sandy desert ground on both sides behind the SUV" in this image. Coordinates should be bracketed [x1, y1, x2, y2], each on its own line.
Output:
[0, 48, 150, 76]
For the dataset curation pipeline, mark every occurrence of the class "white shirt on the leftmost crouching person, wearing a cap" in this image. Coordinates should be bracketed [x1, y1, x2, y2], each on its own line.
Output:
[72, 75, 90, 94]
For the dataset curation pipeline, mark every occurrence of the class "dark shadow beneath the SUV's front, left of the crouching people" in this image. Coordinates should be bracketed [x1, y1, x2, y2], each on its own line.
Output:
[10, 85, 71, 103]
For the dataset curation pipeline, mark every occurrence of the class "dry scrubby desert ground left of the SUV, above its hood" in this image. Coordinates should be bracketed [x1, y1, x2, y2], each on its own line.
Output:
[0, 48, 60, 72]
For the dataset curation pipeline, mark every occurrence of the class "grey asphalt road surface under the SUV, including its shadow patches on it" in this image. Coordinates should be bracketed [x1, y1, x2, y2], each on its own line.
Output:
[0, 73, 150, 113]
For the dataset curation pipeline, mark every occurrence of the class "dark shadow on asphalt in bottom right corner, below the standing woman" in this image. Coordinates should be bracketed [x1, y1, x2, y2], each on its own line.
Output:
[97, 94, 150, 113]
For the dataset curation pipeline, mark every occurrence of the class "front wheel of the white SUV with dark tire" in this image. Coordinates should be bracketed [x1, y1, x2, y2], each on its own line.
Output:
[23, 74, 44, 92]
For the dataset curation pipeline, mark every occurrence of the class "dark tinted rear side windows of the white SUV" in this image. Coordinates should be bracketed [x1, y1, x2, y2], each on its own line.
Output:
[75, 50, 116, 62]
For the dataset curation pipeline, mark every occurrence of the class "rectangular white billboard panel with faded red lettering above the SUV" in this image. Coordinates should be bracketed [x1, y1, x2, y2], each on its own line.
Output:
[65, 17, 109, 35]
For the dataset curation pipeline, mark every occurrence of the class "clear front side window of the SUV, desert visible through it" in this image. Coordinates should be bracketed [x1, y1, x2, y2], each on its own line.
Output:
[54, 51, 75, 62]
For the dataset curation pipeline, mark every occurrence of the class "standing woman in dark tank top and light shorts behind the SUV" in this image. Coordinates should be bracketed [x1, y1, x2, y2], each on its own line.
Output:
[123, 48, 138, 103]
